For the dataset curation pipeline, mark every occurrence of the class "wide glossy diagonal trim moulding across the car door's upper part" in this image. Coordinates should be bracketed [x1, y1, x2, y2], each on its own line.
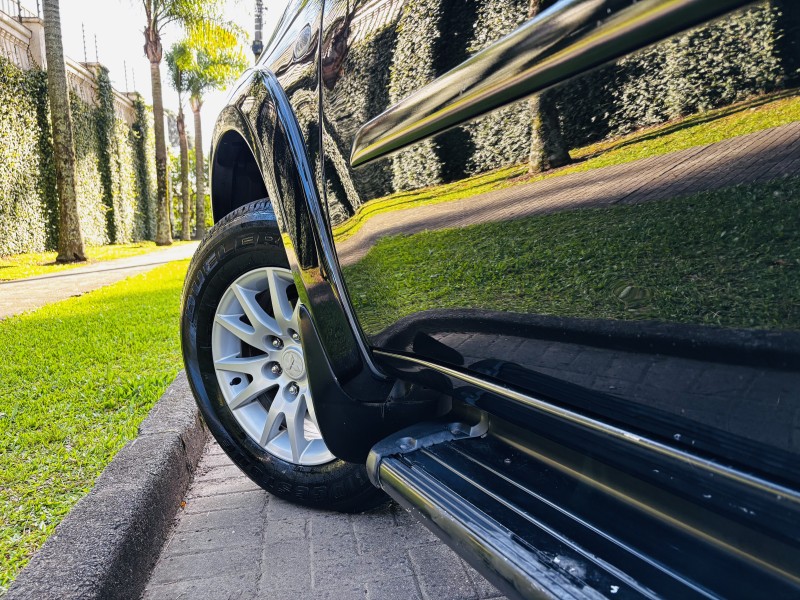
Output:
[350, 0, 752, 167]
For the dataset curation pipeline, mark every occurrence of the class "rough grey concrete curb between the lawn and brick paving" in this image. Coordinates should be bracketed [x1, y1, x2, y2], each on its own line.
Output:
[5, 372, 207, 600]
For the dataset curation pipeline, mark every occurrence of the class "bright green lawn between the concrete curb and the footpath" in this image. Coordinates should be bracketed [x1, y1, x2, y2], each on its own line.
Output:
[0, 261, 188, 595]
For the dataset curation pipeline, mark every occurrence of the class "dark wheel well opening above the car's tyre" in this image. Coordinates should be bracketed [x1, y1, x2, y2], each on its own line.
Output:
[211, 131, 267, 222]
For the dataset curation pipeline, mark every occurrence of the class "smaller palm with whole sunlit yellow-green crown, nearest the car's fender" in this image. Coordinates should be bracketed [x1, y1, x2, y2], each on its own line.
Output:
[185, 27, 247, 238]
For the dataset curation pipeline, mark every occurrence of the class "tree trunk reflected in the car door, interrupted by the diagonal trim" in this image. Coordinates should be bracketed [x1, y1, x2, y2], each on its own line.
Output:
[528, 0, 572, 173]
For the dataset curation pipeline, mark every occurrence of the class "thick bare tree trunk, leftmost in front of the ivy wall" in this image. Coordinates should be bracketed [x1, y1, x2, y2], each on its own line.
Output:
[44, 0, 86, 262]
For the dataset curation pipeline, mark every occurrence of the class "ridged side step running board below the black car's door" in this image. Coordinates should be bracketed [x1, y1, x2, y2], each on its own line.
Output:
[367, 422, 798, 599]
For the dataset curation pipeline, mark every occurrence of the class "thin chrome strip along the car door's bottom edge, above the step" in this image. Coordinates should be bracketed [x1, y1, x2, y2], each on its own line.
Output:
[374, 349, 800, 504]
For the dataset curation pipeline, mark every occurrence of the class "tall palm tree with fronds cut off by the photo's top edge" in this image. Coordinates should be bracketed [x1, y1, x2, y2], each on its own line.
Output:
[142, 0, 221, 246]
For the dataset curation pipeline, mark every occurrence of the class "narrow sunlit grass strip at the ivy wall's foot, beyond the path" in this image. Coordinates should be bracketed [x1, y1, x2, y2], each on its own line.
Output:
[0, 241, 190, 281]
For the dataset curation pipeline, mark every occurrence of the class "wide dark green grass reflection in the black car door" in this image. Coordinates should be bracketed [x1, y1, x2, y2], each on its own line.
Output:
[344, 178, 800, 334]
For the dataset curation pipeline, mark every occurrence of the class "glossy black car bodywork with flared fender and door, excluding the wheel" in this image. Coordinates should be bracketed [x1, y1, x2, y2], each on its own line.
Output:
[206, 0, 800, 597]
